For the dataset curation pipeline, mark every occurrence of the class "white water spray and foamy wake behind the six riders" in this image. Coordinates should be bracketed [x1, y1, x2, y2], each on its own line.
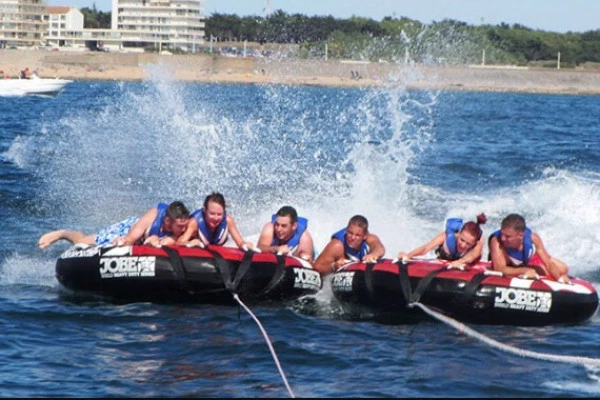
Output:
[5, 61, 600, 280]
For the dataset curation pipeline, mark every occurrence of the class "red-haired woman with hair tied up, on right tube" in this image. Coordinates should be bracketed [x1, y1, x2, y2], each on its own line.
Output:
[398, 213, 487, 267]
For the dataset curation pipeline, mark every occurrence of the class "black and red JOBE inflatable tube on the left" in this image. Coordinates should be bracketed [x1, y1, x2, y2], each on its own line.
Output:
[56, 245, 321, 304]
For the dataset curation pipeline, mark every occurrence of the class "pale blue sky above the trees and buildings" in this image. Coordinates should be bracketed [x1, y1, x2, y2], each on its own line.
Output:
[61, 0, 600, 33]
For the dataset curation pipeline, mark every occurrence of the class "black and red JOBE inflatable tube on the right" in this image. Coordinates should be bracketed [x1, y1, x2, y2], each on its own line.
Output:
[331, 259, 598, 326]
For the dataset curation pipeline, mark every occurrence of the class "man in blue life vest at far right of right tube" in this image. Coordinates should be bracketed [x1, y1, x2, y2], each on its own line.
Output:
[488, 214, 570, 282]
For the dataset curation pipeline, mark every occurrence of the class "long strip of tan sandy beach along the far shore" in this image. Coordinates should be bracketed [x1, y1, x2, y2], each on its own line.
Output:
[0, 50, 600, 94]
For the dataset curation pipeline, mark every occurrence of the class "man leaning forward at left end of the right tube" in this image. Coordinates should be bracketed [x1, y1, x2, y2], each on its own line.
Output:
[313, 215, 385, 275]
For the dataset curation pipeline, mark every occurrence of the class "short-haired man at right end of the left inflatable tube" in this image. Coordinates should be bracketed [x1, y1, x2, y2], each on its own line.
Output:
[257, 206, 315, 262]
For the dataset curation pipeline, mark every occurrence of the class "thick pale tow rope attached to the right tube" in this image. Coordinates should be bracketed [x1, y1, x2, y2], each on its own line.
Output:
[408, 302, 600, 366]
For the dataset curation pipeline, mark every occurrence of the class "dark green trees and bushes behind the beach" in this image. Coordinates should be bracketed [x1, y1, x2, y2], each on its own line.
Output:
[82, 8, 600, 67]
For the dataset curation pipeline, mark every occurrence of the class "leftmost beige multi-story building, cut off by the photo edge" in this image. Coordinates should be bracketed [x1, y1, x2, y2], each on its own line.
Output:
[0, 0, 48, 48]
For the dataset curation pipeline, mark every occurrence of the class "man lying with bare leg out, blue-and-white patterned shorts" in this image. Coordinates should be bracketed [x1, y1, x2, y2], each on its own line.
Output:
[38, 201, 190, 249]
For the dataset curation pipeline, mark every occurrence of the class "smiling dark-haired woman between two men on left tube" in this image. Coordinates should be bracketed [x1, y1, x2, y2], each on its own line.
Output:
[177, 192, 254, 249]
